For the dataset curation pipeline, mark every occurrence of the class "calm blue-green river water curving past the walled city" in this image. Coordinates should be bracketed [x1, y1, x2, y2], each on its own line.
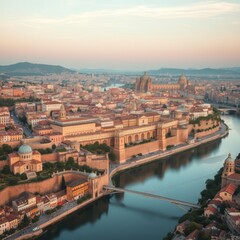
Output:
[39, 116, 240, 240]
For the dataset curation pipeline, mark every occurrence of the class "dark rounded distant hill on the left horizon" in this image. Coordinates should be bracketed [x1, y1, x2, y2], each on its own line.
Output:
[0, 62, 75, 76]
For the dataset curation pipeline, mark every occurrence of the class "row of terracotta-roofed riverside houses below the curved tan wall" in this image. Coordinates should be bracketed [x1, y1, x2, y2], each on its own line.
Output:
[0, 173, 97, 235]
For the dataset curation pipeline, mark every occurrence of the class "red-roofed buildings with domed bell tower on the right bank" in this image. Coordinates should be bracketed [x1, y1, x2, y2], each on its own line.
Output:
[174, 154, 240, 240]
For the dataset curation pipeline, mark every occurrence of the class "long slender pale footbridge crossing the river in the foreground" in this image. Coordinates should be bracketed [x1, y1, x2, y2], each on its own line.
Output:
[103, 185, 201, 208]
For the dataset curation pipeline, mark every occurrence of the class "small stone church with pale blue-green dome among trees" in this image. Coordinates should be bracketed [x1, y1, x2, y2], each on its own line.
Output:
[8, 144, 42, 174]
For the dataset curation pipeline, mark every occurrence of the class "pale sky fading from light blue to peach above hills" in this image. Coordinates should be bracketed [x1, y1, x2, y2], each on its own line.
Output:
[0, 0, 240, 70]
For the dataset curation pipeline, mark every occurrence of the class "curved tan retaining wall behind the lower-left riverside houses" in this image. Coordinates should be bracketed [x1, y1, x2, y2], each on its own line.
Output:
[0, 174, 82, 206]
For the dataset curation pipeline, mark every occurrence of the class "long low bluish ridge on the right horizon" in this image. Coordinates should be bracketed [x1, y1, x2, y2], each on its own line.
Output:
[148, 67, 240, 76]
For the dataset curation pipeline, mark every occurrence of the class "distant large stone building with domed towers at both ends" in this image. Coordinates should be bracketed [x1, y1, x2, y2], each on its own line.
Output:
[135, 72, 189, 92]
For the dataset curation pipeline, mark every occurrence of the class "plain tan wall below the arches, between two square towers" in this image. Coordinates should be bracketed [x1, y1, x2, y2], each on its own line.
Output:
[125, 141, 159, 159]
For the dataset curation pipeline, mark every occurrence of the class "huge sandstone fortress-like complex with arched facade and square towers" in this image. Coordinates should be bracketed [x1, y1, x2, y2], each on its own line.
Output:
[51, 104, 189, 162]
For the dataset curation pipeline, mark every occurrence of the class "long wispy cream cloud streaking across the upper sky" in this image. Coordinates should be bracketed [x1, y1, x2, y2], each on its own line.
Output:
[21, 1, 240, 24]
